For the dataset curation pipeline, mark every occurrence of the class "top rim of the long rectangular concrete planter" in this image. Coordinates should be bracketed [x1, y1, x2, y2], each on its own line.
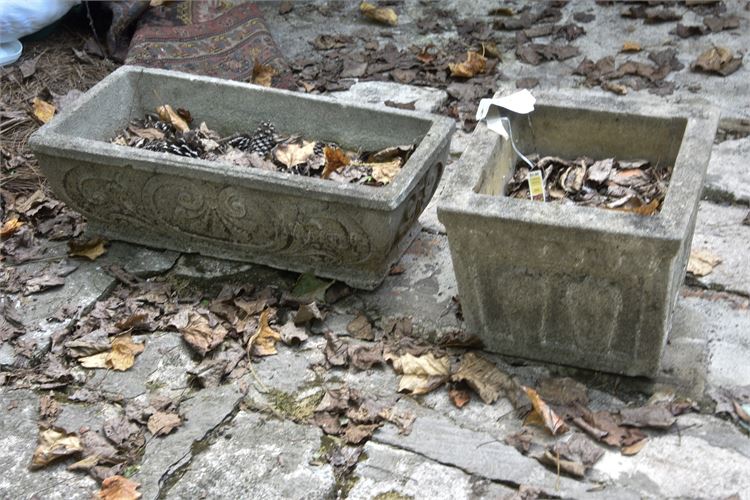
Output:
[29, 65, 455, 211]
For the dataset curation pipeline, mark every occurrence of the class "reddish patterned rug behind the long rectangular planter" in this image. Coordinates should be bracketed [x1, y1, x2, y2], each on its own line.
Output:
[94, 0, 294, 89]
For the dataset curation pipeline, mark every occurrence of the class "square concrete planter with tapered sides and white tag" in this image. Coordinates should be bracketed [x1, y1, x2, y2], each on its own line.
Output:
[438, 95, 718, 376]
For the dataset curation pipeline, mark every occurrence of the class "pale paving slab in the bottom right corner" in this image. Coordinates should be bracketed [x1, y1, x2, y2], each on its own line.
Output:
[594, 415, 750, 500]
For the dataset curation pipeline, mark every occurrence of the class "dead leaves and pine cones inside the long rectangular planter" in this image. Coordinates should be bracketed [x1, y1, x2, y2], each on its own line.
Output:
[111, 110, 416, 186]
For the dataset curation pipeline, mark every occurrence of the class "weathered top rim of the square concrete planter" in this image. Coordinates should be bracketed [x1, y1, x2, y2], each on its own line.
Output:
[437, 92, 719, 250]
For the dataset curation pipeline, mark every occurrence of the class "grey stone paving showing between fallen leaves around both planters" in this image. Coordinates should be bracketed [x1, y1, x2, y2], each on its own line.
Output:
[0, 1, 750, 500]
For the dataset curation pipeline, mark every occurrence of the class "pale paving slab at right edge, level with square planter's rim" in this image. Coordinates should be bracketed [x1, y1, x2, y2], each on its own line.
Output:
[704, 136, 750, 205]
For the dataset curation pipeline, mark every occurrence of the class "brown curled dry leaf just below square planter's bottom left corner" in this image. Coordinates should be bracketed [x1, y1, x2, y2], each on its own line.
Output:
[451, 352, 519, 408]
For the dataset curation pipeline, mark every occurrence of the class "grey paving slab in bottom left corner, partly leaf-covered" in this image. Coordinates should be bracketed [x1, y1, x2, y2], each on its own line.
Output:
[0, 389, 97, 500]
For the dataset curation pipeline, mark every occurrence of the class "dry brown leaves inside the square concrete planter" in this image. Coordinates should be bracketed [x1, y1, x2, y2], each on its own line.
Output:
[506, 155, 672, 215]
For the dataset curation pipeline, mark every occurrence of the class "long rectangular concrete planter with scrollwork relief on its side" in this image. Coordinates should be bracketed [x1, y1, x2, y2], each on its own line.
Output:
[30, 67, 454, 288]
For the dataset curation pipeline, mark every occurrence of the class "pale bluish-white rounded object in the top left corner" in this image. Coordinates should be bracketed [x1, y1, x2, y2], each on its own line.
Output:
[0, 0, 81, 66]
